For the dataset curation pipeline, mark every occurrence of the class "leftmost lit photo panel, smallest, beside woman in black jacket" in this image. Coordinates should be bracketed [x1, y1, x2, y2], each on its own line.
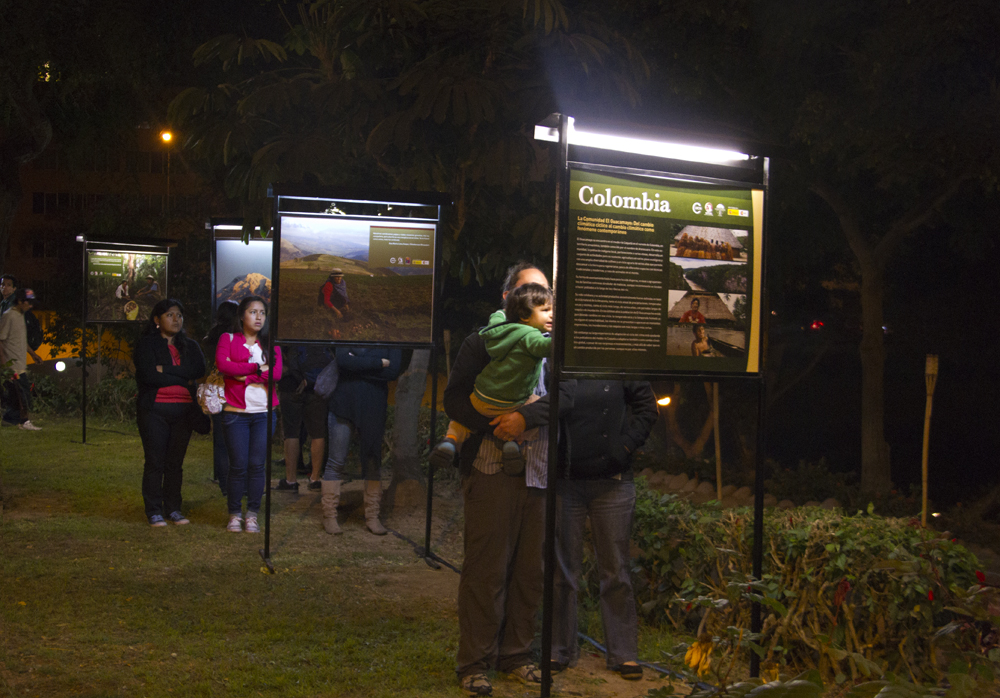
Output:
[87, 250, 167, 322]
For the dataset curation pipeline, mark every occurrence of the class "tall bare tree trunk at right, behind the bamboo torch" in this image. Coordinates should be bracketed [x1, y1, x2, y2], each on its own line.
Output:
[861, 264, 892, 495]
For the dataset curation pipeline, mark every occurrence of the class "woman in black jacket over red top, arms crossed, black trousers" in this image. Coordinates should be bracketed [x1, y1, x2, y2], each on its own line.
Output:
[132, 298, 205, 527]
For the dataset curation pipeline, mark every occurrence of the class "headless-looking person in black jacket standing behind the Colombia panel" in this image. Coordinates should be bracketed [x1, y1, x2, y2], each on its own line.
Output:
[552, 380, 657, 680]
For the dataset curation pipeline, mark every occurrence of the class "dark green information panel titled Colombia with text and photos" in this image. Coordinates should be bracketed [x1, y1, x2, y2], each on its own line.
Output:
[564, 166, 764, 374]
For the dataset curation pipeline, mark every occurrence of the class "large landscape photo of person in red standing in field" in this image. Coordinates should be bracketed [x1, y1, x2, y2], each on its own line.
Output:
[276, 215, 435, 342]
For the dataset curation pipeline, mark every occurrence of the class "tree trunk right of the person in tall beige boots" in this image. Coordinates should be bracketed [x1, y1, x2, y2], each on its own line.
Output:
[384, 349, 430, 513]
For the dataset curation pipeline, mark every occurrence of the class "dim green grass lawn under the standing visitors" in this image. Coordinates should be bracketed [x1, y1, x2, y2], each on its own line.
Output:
[0, 418, 688, 698]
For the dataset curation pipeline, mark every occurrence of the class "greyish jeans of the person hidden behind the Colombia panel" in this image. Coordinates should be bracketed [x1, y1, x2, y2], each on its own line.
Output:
[552, 479, 639, 668]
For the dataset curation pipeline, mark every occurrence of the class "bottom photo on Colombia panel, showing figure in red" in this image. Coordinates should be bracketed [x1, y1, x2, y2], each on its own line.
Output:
[666, 291, 747, 358]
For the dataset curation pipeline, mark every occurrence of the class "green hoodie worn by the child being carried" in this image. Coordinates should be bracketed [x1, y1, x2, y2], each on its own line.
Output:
[476, 310, 552, 409]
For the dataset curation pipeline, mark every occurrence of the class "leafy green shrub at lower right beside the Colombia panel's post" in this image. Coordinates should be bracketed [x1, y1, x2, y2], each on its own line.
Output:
[633, 480, 977, 678]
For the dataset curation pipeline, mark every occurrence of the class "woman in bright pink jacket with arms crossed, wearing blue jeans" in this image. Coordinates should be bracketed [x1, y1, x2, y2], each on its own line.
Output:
[215, 296, 281, 533]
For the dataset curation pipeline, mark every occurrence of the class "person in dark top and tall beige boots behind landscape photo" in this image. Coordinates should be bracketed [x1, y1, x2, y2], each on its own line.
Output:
[321, 347, 403, 536]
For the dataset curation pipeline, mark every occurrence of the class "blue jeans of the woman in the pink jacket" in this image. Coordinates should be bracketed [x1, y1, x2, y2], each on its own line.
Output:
[222, 412, 274, 515]
